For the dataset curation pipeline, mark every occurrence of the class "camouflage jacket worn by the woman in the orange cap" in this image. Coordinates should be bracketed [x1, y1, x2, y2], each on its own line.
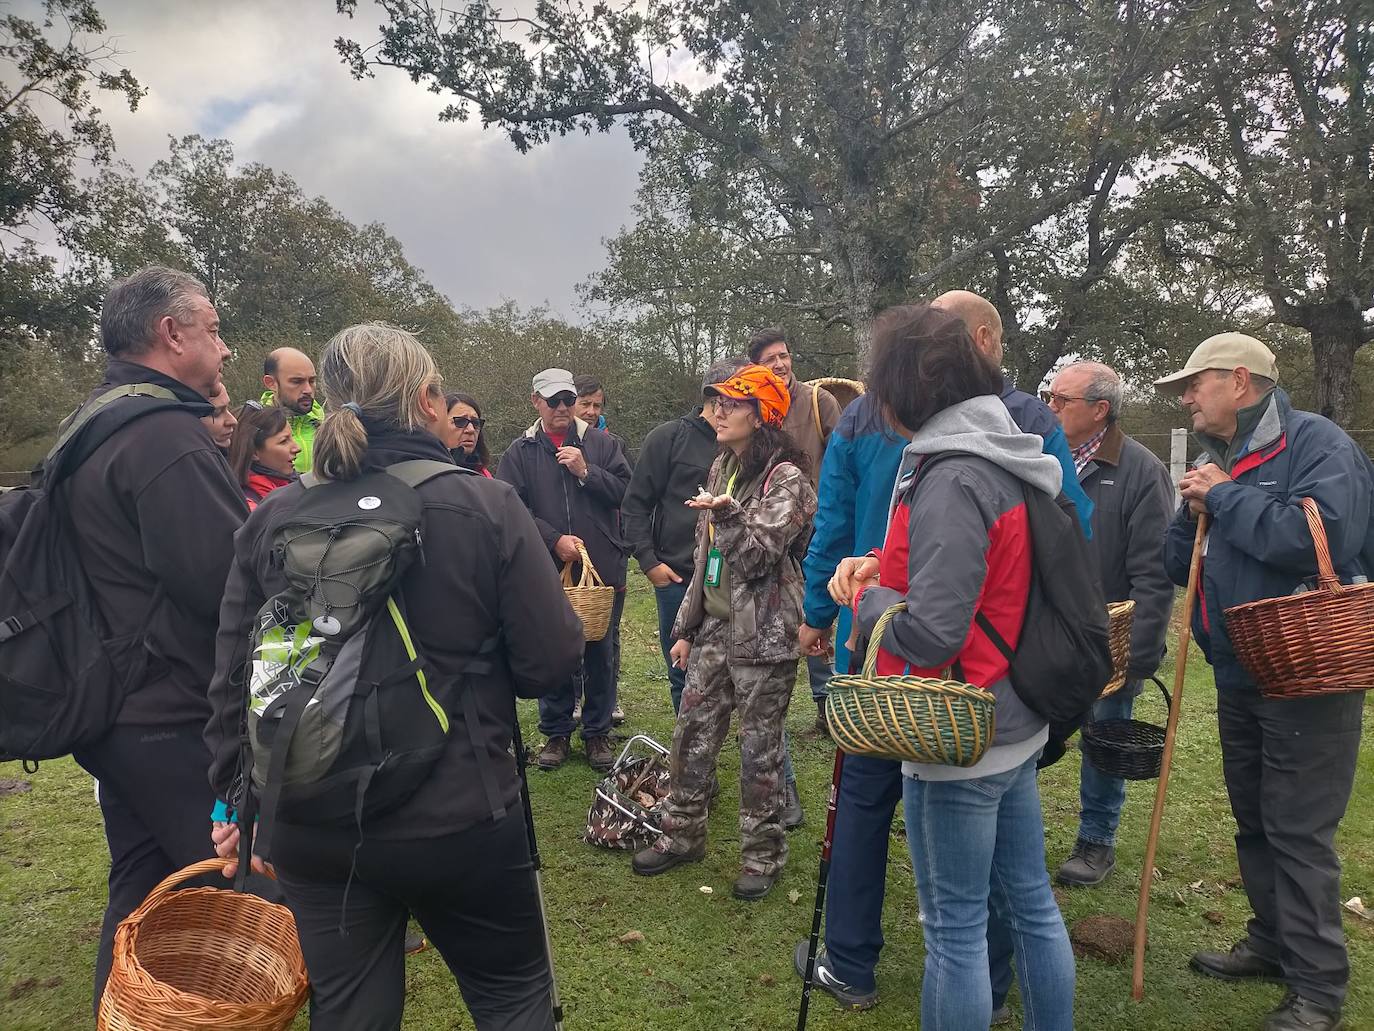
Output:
[673, 458, 816, 665]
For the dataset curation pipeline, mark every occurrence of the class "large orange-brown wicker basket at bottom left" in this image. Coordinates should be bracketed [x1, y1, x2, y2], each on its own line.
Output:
[96, 859, 311, 1031]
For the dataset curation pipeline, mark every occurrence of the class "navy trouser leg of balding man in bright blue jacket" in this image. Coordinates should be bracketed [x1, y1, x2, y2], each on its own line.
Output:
[826, 755, 901, 991]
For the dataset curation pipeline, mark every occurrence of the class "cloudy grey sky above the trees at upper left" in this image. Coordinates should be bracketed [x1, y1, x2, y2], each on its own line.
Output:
[77, 0, 640, 318]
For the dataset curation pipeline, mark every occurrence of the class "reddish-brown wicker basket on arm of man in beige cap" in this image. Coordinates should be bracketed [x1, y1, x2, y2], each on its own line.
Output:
[1226, 498, 1374, 698]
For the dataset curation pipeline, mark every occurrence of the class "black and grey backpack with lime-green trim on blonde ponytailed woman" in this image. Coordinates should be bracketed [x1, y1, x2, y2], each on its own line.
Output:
[229, 461, 504, 866]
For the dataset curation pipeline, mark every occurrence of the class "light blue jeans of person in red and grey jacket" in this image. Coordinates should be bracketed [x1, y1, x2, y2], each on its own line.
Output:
[903, 757, 1074, 1031]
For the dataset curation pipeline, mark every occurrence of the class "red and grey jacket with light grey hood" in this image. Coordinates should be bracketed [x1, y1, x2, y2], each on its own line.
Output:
[856, 396, 1062, 779]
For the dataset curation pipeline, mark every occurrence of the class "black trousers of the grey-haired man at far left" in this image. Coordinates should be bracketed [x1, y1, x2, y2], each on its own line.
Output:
[76, 722, 282, 1009]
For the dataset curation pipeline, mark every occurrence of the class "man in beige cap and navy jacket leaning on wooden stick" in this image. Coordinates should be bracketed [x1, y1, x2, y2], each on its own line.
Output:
[1156, 333, 1374, 1031]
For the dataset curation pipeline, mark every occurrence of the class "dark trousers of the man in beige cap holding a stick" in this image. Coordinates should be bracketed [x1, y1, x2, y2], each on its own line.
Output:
[1217, 690, 1364, 1009]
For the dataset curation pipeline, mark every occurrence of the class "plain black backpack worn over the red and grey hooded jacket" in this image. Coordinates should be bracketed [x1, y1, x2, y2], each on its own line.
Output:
[974, 487, 1112, 767]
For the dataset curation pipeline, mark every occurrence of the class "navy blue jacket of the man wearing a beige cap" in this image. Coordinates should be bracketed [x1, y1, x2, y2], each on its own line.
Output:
[1164, 389, 1374, 690]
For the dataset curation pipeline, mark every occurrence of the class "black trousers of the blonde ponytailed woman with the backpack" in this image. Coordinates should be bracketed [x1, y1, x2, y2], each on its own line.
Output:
[272, 811, 554, 1031]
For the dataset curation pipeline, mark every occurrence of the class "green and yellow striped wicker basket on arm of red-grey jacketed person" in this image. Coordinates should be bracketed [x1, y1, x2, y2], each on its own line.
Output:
[826, 603, 998, 766]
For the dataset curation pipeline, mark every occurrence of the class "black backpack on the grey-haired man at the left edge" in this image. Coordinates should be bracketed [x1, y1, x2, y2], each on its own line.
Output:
[0, 384, 183, 763]
